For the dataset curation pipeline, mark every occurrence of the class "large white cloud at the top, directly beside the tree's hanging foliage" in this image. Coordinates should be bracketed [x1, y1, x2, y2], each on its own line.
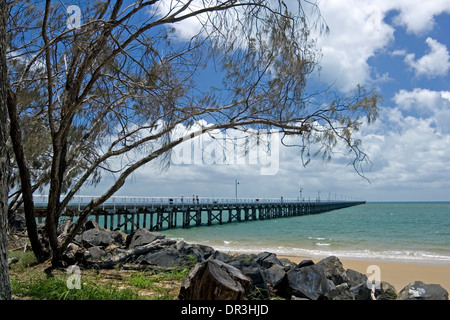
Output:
[312, 0, 394, 91]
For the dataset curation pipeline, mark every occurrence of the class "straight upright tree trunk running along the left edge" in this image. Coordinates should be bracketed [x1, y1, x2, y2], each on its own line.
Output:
[0, 0, 11, 300]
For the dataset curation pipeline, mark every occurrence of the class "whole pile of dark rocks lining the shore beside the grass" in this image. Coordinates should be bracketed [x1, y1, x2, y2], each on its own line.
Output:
[59, 220, 448, 300]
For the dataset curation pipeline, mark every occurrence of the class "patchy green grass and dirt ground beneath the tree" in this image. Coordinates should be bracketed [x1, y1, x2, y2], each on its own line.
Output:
[9, 252, 190, 300]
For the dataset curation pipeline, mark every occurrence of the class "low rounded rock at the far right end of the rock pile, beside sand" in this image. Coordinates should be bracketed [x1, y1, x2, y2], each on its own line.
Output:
[397, 281, 448, 300]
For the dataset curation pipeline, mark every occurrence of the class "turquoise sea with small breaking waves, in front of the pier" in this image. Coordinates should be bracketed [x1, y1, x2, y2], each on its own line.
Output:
[162, 202, 450, 266]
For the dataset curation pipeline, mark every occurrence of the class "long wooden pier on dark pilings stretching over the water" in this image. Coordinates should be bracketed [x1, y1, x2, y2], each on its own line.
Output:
[35, 197, 366, 232]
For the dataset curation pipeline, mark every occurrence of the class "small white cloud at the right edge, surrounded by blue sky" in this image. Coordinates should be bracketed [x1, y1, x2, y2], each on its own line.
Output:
[404, 37, 450, 78]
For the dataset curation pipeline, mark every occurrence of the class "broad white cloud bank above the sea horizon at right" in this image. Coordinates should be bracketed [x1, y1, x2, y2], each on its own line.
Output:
[352, 89, 450, 201]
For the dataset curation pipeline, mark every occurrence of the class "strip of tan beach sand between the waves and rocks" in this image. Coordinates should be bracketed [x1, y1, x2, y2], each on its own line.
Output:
[278, 256, 450, 293]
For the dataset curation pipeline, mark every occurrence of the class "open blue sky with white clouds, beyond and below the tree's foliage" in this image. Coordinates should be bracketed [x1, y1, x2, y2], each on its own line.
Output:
[84, 0, 450, 201]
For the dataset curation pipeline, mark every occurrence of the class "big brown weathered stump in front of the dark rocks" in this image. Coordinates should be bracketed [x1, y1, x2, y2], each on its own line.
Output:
[178, 259, 252, 300]
